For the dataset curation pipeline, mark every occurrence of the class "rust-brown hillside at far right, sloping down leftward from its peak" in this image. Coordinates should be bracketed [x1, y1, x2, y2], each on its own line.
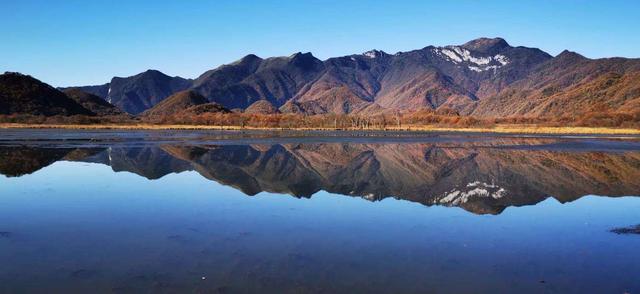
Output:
[465, 51, 640, 117]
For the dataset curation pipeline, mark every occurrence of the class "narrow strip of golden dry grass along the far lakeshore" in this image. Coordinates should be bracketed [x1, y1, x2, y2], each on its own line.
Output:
[0, 123, 640, 135]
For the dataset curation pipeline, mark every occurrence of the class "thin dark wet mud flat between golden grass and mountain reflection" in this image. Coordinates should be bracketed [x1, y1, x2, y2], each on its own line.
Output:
[0, 129, 640, 151]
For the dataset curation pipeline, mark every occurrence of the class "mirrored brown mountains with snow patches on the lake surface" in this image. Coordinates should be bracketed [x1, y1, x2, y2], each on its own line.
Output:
[0, 138, 640, 214]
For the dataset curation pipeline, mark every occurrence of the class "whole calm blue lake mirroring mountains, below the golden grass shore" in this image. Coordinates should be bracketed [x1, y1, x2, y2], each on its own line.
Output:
[0, 130, 640, 293]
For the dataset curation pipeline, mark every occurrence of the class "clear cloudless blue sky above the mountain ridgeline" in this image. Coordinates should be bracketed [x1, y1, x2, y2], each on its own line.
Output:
[0, 0, 640, 86]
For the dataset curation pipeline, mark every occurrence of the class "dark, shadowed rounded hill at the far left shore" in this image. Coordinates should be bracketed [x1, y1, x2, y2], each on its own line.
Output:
[0, 72, 95, 116]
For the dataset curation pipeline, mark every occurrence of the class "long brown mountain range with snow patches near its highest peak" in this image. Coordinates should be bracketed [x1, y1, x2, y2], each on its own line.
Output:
[0, 38, 640, 117]
